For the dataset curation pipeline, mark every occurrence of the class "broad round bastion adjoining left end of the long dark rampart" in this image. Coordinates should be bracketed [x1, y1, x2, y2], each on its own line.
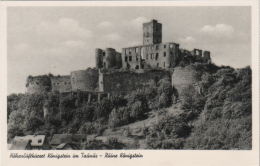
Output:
[71, 68, 99, 91]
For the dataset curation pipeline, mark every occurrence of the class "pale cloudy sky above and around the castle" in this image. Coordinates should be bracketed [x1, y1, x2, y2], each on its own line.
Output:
[7, 6, 252, 94]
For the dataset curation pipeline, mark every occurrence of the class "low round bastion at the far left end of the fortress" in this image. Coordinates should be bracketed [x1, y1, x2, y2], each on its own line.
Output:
[26, 75, 51, 93]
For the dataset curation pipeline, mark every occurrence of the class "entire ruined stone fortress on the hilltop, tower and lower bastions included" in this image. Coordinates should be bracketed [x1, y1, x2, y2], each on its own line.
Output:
[26, 20, 211, 94]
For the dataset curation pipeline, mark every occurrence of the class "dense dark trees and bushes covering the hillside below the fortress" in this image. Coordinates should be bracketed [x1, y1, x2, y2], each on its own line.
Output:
[7, 63, 252, 149]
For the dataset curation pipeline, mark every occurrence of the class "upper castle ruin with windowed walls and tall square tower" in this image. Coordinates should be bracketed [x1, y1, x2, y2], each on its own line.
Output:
[96, 20, 211, 70]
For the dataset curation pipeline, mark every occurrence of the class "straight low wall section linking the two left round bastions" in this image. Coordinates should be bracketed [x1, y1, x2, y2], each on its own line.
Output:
[51, 76, 72, 92]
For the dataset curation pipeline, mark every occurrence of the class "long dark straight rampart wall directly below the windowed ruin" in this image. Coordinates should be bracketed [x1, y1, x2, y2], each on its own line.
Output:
[100, 70, 171, 93]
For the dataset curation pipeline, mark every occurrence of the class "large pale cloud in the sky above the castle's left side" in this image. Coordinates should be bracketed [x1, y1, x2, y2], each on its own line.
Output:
[37, 18, 92, 40]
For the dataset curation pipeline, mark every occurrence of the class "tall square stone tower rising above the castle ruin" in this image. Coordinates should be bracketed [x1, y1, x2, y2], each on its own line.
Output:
[143, 20, 162, 45]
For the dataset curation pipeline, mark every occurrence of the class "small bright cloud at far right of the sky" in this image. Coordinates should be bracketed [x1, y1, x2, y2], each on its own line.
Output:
[200, 24, 234, 37]
